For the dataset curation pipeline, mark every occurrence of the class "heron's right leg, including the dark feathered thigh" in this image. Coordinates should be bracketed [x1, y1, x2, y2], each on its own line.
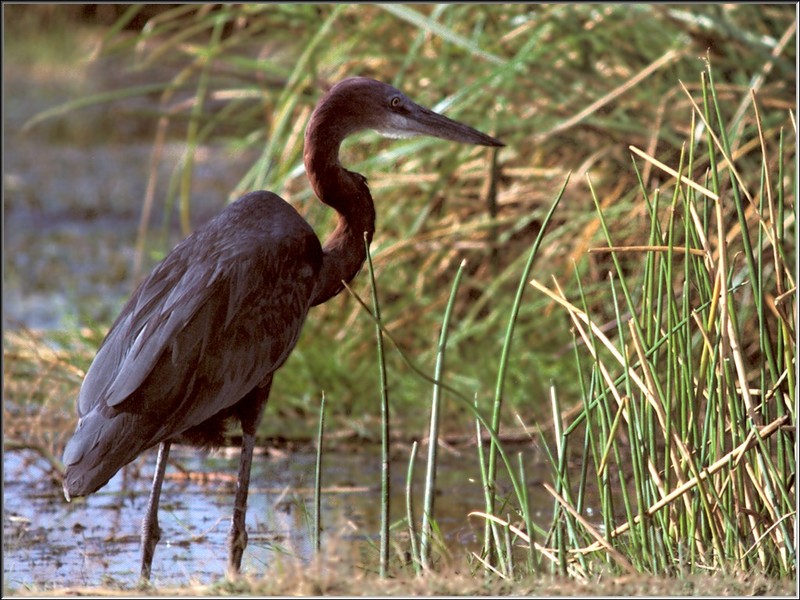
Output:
[228, 378, 272, 576]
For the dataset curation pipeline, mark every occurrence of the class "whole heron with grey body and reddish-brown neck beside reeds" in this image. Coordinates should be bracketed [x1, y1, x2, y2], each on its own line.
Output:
[63, 77, 503, 581]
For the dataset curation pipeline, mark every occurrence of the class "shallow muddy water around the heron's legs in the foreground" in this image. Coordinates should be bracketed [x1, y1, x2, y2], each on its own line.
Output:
[3, 446, 552, 589]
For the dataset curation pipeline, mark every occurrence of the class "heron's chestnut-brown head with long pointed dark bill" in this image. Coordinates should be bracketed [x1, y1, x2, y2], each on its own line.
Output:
[309, 77, 504, 146]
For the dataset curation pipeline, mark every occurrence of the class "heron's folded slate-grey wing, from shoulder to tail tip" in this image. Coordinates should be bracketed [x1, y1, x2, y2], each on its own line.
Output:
[64, 192, 322, 495]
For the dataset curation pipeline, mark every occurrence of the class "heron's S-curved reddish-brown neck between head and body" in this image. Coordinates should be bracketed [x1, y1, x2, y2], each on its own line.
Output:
[304, 129, 375, 306]
